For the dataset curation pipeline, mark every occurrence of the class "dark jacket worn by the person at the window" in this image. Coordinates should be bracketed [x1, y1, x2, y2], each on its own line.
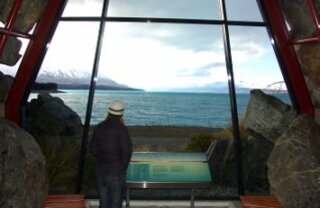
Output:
[91, 116, 132, 175]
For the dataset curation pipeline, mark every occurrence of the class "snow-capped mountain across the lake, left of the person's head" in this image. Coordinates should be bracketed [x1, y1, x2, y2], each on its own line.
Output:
[36, 70, 141, 90]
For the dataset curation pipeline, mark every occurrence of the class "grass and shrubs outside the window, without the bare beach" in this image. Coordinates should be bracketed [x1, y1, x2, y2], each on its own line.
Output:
[36, 122, 249, 194]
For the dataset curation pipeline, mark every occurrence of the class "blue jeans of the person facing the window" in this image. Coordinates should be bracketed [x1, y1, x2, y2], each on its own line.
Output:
[97, 175, 126, 208]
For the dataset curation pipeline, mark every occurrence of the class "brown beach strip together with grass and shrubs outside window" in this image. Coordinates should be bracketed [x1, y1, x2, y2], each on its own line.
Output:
[36, 122, 247, 194]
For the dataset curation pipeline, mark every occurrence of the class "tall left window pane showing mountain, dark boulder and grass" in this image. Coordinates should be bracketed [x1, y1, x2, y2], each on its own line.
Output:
[26, 22, 99, 194]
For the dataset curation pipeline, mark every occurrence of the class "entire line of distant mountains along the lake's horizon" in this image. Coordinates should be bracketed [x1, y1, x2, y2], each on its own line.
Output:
[1, 70, 287, 94]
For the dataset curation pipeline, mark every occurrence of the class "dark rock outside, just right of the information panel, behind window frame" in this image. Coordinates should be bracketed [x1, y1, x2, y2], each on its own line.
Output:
[208, 136, 273, 194]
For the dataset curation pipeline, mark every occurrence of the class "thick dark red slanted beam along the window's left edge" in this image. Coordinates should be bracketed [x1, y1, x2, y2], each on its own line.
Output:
[5, 0, 66, 124]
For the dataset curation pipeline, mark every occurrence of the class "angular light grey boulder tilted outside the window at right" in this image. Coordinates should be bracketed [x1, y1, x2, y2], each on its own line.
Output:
[244, 90, 296, 142]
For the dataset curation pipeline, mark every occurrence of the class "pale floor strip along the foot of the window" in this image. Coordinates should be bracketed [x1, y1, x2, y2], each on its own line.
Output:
[86, 200, 241, 208]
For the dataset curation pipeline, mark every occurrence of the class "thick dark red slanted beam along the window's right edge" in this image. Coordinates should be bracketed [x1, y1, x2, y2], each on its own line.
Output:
[261, 0, 314, 117]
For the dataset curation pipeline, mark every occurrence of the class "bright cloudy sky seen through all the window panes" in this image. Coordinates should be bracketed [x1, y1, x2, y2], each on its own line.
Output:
[0, 0, 282, 91]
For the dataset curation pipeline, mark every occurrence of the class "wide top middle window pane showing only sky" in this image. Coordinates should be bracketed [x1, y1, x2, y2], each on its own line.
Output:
[108, 0, 221, 19]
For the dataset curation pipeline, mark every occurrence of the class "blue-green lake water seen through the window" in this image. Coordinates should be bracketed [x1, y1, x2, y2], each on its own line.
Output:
[29, 90, 290, 127]
